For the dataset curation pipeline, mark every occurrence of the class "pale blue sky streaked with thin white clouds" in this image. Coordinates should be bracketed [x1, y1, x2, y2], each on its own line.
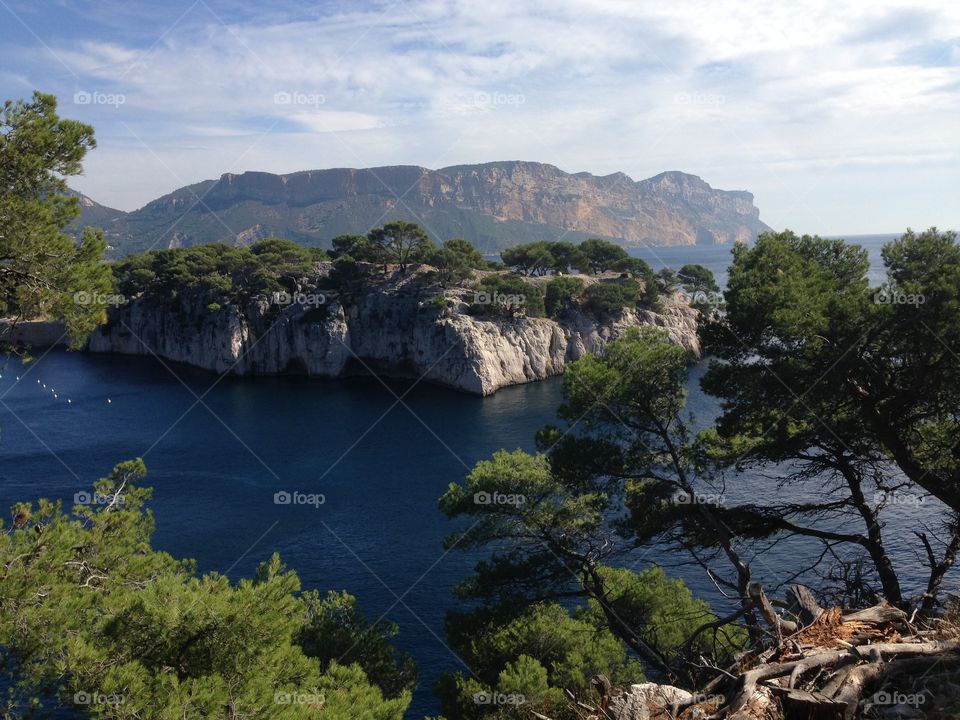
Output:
[0, 0, 960, 235]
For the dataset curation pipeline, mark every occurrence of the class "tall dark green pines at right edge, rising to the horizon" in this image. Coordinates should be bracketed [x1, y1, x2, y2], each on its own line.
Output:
[703, 228, 960, 606]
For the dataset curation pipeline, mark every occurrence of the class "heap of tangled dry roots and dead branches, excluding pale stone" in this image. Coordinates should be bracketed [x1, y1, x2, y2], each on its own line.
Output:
[711, 586, 960, 720]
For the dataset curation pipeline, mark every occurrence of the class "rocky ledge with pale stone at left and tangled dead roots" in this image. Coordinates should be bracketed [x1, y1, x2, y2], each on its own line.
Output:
[547, 585, 960, 720]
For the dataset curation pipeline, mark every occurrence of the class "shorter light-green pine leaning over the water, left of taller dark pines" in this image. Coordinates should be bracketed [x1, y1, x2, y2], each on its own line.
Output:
[440, 328, 742, 718]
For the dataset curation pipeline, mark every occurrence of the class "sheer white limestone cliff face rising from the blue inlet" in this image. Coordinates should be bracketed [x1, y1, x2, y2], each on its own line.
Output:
[88, 283, 700, 395]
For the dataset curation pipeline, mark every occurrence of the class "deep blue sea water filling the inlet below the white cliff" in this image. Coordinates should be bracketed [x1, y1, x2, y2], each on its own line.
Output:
[0, 233, 936, 718]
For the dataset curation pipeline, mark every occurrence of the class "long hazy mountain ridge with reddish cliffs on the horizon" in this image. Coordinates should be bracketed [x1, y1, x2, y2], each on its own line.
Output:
[73, 161, 768, 257]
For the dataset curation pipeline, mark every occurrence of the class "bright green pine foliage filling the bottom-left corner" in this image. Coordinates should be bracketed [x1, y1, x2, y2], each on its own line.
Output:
[0, 460, 416, 720]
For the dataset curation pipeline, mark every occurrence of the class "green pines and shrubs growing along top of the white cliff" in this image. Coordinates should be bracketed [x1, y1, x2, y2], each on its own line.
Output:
[113, 221, 688, 323]
